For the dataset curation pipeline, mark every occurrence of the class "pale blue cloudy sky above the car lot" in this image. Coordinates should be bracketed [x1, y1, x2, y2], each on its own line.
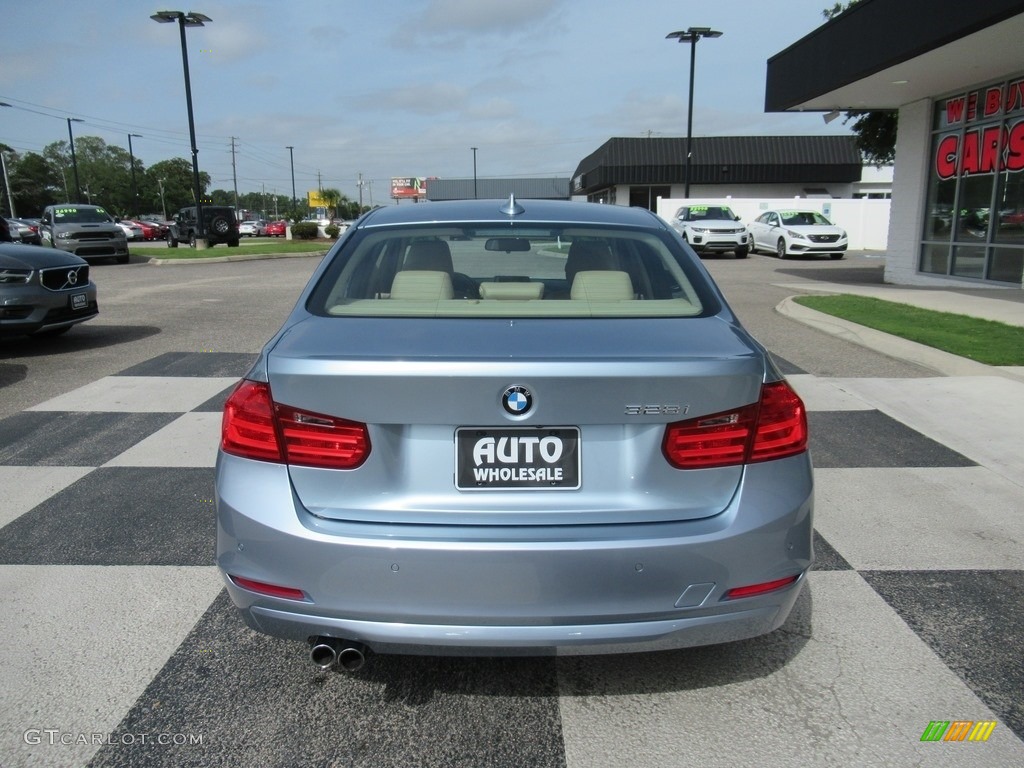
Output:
[0, 0, 849, 204]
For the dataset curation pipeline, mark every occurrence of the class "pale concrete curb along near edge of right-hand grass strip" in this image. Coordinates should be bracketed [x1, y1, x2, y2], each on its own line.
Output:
[775, 296, 1024, 381]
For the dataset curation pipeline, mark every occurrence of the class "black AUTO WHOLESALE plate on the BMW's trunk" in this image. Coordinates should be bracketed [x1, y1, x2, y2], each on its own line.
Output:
[455, 427, 580, 490]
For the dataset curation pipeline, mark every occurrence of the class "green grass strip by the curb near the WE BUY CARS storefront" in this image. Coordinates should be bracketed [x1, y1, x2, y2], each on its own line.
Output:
[794, 294, 1024, 366]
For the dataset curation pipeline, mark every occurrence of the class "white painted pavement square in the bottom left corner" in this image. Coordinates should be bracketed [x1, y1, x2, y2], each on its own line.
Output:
[0, 565, 223, 766]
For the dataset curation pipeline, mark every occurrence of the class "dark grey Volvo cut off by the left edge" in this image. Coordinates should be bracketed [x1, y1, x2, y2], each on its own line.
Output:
[0, 243, 99, 337]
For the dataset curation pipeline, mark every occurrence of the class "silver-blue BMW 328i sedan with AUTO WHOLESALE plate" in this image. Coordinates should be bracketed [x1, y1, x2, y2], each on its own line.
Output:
[216, 199, 813, 670]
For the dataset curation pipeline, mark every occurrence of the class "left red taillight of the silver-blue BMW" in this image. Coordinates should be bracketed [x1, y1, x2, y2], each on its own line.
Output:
[220, 381, 370, 469]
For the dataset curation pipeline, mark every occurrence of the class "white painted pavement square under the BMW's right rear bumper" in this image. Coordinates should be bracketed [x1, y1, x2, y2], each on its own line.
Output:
[558, 571, 1024, 768]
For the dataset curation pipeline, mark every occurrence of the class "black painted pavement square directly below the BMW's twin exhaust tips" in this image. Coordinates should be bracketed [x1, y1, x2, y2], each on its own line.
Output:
[90, 593, 565, 768]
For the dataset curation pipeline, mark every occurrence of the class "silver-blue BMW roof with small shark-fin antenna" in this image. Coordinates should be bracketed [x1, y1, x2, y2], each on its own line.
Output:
[357, 199, 665, 228]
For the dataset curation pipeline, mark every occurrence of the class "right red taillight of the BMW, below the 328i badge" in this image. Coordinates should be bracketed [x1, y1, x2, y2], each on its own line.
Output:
[663, 381, 807, 469]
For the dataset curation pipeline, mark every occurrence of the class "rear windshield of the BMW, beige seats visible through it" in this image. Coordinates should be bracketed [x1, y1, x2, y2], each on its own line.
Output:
[307, 225, 714, 317]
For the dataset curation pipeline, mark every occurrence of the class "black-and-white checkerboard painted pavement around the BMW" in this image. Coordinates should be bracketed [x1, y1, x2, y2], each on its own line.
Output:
[0, 352, 1024, 766]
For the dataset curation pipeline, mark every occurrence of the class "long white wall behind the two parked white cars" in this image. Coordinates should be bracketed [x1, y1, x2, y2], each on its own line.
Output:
[657, 196, 892, 251]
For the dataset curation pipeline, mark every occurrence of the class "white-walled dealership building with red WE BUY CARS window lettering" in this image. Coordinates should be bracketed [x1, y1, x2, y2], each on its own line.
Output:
[765, 0, 1024, 288]
